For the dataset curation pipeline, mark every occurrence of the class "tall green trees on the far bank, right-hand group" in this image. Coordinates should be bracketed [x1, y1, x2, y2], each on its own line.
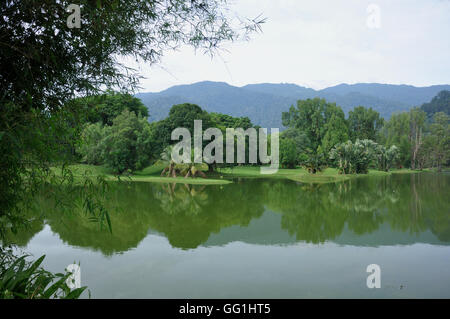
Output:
[280, 95, 450, 173]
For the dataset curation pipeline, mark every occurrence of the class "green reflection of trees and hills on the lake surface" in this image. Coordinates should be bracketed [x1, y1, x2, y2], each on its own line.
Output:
[9, 173, 450, 255]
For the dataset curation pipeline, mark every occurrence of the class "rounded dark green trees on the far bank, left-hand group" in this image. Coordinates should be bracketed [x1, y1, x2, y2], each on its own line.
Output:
[76, 93, 257, 174]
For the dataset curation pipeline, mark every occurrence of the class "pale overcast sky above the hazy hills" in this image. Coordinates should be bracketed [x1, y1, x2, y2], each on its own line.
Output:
[132, 0, 450, 92]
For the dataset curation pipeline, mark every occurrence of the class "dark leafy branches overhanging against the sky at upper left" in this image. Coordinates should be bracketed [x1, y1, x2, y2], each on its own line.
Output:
[0, 0, 265, 109]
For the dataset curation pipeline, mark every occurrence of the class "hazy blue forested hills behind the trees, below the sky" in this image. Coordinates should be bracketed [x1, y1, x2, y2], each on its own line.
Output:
[136, 81, 450, 128]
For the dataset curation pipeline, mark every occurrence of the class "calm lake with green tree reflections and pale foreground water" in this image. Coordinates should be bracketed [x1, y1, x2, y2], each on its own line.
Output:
[7, 173, 450, 298]
